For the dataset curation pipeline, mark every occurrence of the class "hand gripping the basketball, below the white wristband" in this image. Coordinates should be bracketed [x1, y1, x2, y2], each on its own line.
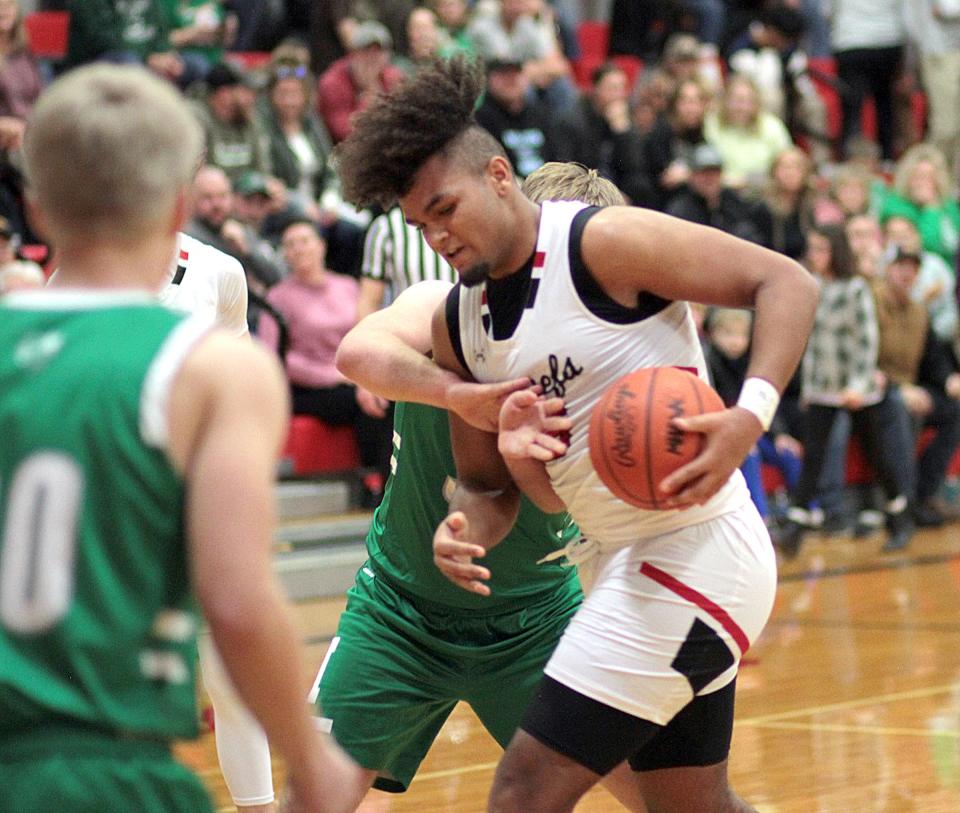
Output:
[660, 407, 763, 508]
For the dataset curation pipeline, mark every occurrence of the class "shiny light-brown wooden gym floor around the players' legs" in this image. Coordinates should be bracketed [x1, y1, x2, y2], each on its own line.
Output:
[178, 525, 960, 813]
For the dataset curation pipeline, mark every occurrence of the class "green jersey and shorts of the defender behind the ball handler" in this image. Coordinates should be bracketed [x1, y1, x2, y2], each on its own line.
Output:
[314, 403, 581, 791]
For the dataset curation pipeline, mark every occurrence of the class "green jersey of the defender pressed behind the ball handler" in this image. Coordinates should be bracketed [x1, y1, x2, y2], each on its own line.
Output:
[367, 403, 579, 611]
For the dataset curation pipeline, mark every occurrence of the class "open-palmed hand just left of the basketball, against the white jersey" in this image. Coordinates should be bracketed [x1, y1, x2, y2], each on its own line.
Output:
[497, 387, 573, 463]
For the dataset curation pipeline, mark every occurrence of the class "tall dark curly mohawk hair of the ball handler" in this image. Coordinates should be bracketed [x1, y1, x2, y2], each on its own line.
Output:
[334, 56, 488, 209]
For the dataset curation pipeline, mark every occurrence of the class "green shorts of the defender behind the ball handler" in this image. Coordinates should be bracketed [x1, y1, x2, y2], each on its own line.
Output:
[317, 563, 582, 792]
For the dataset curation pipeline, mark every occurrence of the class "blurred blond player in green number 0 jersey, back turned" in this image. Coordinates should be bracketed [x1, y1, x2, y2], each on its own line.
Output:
[0, 66, 366, 813]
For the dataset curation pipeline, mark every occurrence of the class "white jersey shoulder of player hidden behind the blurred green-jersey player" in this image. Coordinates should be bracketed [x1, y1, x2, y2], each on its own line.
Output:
[160, 232, 247, 336]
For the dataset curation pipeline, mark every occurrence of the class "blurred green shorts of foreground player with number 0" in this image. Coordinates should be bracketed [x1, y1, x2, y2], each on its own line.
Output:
[0, 726, 213, 813]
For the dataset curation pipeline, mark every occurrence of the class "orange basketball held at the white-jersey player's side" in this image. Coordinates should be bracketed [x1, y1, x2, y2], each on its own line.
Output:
[589, 367, 724, 510]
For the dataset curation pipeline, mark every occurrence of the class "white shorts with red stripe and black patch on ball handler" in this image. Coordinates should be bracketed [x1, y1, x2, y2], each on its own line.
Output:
[545, 503, 777, 725]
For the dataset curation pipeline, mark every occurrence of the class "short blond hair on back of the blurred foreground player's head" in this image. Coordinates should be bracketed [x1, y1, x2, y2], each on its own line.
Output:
[23, 64, 203, 243]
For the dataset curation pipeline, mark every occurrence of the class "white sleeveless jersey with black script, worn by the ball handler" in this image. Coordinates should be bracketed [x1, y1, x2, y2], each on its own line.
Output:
[451, 202, 750, 550]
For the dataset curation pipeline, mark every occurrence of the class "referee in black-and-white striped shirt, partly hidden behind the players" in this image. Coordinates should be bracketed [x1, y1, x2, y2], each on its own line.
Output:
[357, 206, 457, 322]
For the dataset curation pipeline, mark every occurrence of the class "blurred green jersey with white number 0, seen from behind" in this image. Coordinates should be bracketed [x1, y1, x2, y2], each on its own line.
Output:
[0, 291, 210, 738]
